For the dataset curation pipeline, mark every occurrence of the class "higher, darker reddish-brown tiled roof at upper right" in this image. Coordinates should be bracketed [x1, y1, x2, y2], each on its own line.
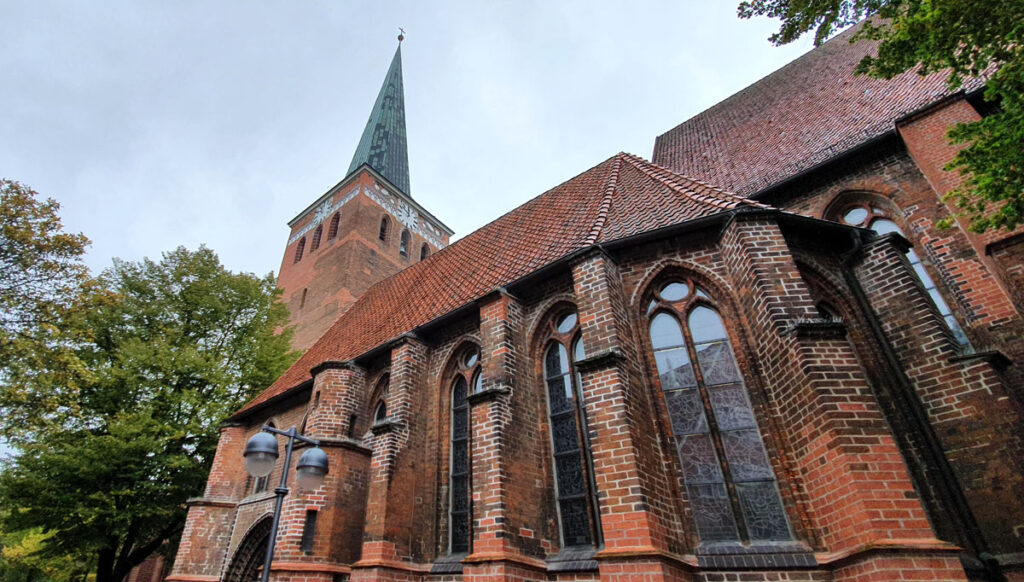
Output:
[653, 22, 983, 196]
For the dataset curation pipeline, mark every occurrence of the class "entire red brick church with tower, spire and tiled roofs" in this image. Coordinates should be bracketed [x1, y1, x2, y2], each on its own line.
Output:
[168, 24, 1024, 582]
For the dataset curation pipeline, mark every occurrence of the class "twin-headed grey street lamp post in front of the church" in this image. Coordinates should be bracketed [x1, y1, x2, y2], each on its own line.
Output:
[243, 426, 328, 582]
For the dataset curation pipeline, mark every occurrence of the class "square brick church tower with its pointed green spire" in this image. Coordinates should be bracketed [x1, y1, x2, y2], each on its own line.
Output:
[278, 42, 453, 349]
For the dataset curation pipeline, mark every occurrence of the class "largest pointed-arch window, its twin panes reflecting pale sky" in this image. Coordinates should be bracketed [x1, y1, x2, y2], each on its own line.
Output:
[647, 280, 791, 543]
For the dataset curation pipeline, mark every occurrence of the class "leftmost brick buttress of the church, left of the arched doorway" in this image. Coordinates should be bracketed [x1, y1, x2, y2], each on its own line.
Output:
[167, 423, 247, 582]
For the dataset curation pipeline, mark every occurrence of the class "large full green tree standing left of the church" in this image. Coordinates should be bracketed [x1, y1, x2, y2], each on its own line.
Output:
[0, 248, 295, 582]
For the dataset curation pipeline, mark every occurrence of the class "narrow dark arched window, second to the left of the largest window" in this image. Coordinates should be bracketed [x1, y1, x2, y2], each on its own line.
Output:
[449, 346, 480, 553]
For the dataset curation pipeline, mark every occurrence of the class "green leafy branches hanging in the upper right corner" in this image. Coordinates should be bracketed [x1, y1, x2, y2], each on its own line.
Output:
[738, 0, 1024, 233]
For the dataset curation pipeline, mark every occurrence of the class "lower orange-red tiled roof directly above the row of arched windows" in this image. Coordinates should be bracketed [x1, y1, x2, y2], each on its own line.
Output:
[236, 154, 769, 417]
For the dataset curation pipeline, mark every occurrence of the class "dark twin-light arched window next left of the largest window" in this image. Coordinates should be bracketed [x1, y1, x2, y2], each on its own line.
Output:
[544, 311, 600, 547]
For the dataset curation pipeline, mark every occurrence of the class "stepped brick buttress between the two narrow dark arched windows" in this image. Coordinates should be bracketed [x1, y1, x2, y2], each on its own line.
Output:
[463, 291, 546, 581]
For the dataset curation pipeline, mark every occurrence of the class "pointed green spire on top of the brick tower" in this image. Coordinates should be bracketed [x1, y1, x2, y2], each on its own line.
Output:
[348, 41, 411, 196]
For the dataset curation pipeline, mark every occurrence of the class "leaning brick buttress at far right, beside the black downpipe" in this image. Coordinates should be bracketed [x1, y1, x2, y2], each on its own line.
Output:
[854, 231, 1024, 554]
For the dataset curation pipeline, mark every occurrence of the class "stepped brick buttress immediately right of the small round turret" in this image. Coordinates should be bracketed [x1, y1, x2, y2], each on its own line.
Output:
[352, 335, 427, 582]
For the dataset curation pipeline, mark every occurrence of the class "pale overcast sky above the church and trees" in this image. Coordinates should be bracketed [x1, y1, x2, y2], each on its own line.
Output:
[0, 0, 810, 274]
